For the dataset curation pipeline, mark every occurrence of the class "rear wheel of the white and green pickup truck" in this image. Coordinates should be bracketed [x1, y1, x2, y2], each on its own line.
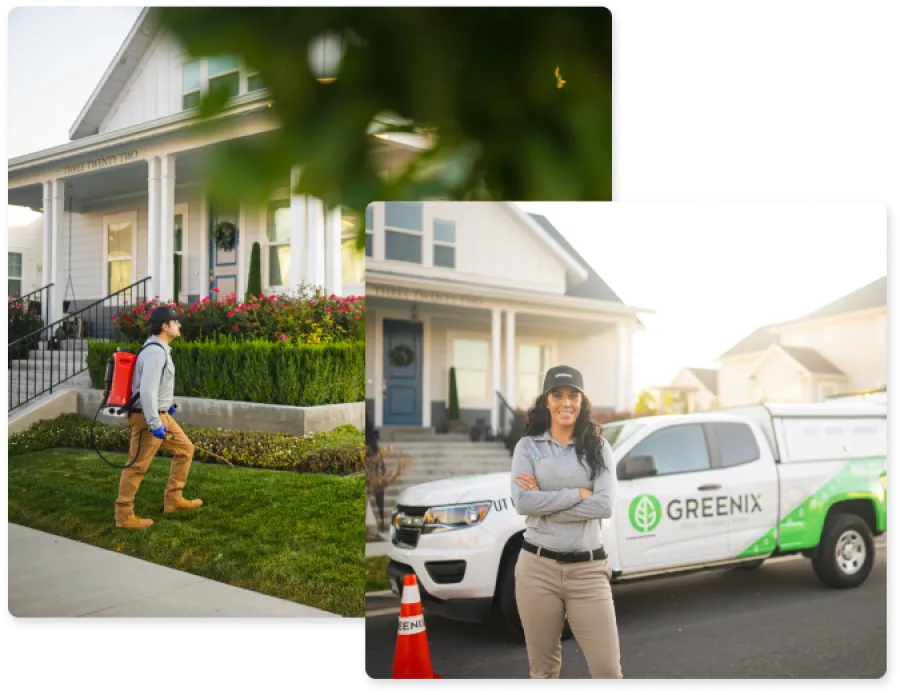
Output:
[812, 514, 875, 589]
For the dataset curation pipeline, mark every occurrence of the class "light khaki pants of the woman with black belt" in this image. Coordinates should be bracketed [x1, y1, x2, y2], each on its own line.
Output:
[515, 550, 622, 679]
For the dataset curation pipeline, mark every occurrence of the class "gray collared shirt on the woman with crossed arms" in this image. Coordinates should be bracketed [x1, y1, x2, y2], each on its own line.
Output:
[510, 432, 617, 552]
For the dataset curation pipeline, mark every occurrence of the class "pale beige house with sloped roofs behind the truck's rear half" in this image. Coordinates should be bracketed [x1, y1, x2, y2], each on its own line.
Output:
[718, 276, 888, 407]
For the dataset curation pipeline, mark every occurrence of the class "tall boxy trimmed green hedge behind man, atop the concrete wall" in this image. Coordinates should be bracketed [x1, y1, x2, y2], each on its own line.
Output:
[87, 338, 366, 407]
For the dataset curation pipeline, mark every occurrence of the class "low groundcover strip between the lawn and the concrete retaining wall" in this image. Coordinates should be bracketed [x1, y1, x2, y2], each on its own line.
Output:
[8, 413, 365, 475]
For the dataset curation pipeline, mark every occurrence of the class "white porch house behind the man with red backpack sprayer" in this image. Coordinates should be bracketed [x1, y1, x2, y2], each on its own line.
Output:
[7, 6, 415, 332]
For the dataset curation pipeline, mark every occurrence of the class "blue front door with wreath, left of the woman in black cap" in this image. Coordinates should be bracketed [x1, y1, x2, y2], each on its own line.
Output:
[382, 319, 423, 425]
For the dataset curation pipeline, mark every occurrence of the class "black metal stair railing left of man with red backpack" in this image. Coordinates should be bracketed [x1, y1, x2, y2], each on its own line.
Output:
[5, 277, 150, 412]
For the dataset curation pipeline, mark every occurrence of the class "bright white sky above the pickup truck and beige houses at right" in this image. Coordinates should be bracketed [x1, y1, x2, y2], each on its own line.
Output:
[517, 200, 888, 391]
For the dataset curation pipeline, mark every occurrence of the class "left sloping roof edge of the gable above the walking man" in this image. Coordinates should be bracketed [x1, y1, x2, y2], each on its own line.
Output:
[69, 5, 159, 140]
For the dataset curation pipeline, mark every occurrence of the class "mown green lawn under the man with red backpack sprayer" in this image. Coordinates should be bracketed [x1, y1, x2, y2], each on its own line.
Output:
[8, 449, 366, 618]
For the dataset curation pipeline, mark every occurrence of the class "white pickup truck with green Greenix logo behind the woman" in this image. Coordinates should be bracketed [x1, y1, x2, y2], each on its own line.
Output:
[387, 402, 887, 638]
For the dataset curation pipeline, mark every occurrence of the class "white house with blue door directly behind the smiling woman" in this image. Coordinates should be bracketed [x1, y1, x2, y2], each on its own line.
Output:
[366, 201, 645, 433]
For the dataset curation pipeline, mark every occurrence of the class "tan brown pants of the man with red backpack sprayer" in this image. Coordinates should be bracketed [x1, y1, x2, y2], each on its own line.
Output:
[116, 413, 194, 521]
